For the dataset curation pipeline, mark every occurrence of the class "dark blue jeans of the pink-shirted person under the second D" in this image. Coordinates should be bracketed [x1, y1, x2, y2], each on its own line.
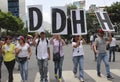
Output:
[54, 56, 64, 78]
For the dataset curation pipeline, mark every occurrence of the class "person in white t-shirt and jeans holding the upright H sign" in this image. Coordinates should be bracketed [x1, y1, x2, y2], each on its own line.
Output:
[72, 35, 86, 82]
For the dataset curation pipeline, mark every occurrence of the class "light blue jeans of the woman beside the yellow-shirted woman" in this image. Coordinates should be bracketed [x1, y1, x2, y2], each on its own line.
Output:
[19, 60, 28, 81]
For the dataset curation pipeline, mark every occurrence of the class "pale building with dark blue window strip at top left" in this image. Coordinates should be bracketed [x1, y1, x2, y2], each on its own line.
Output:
[0, 0, 26, 25]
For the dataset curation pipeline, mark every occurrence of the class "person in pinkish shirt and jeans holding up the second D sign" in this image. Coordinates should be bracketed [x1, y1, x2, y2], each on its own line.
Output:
[50, 35, 65, 82]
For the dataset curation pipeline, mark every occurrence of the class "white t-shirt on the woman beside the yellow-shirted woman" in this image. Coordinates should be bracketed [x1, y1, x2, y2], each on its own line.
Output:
[16, 43, 30, 57]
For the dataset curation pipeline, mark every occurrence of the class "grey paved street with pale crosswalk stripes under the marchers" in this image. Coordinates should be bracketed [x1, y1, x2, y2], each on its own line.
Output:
[2, 45, 120, 82]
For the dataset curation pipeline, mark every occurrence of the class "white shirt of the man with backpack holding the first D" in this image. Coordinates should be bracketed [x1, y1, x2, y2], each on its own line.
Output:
[35, 38, 50, 59]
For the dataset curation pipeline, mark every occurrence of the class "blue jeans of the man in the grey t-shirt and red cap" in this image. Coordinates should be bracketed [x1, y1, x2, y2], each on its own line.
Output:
[97, 53, 110, 76]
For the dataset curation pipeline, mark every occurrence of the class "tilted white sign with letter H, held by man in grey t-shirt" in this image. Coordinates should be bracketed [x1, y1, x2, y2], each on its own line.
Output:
[95, 11, 115, 31]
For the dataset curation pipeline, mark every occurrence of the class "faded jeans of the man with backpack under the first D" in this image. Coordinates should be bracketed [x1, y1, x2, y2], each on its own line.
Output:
[38, 58, 48, 79]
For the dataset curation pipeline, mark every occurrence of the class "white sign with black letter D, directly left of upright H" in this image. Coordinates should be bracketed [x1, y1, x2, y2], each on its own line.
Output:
[51, 6, 67, 34]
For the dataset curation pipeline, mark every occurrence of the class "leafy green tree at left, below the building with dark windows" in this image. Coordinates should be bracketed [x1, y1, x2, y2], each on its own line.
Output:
[0, 12, 24, 34]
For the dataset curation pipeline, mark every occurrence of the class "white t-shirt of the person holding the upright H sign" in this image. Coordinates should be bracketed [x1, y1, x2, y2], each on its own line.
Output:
[72, 40, 84, 56]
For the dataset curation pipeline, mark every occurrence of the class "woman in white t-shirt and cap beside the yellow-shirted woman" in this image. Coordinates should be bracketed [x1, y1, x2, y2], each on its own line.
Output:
[16, 36, 31, 82]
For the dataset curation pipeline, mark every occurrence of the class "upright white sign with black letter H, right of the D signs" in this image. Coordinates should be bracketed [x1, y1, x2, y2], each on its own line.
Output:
[71, 9, 87, 35]
